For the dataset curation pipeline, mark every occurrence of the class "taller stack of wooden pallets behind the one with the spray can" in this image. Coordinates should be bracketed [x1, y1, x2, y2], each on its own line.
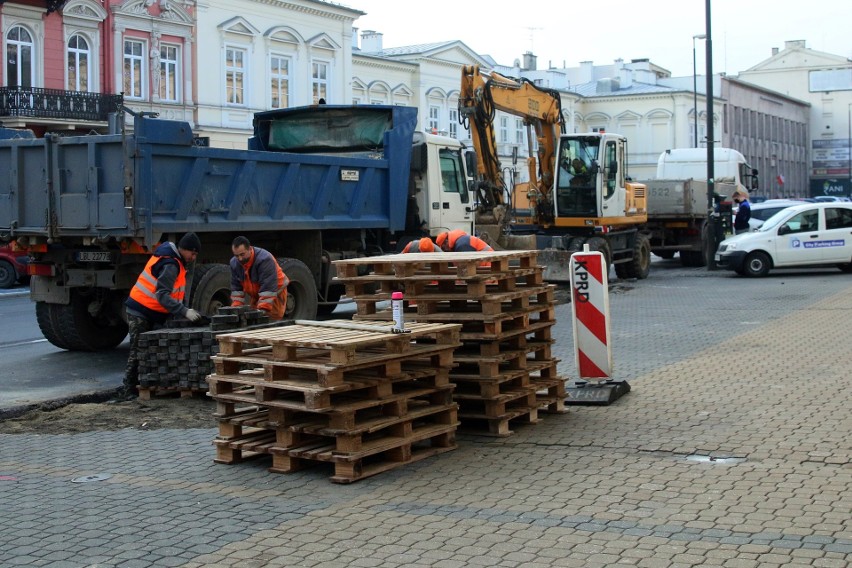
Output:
[334, 251, 566, 436]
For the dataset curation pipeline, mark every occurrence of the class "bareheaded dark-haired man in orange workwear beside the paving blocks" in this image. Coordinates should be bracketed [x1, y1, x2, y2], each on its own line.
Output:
[231, 236, 290, 320]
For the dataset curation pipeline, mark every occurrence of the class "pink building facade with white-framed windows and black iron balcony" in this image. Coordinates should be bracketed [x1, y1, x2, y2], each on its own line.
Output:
[0, 0, 195, 135]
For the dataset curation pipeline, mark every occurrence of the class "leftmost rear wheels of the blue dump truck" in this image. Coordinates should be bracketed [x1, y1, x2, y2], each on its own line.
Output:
[43, 290, 127, 351]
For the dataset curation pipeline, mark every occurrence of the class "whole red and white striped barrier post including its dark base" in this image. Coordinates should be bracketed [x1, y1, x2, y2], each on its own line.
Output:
[565, 245, 630, 404]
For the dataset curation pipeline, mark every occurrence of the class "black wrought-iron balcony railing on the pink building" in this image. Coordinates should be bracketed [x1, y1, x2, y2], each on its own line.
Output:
[0, 87, 124, 122]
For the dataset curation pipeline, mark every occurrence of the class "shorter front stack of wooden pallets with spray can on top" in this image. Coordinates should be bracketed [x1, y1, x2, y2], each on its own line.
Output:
[207, 321, 460, 483]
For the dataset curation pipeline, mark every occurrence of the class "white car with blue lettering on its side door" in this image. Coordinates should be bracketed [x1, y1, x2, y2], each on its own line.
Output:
[716, 202, 852, 276]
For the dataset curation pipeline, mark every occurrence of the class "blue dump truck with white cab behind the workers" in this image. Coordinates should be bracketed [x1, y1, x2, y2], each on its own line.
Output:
[0, 105, 473, 351]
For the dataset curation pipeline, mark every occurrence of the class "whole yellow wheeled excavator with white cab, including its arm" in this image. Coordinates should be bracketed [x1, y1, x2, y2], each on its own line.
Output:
[459, 65, 651, 281]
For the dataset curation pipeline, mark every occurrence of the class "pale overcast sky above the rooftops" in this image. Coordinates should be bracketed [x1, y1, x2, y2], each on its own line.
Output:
[338, 0, 852, 76]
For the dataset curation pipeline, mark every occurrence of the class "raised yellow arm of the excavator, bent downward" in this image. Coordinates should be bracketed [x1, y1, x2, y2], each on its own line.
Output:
[459, 65, 565, 223]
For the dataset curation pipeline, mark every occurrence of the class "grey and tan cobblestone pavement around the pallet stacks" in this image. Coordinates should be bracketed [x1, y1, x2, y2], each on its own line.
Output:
[0, 270, 852, 568]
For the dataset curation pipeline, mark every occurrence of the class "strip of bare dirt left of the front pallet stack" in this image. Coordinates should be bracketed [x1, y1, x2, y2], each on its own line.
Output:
[0, 396, 216, 434]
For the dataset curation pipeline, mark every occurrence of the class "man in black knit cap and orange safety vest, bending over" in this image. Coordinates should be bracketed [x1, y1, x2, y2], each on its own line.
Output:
[124, 233, 202, 396]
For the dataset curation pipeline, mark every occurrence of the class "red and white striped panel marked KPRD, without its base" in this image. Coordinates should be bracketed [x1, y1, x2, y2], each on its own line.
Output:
[571, 252, 612, 380]
